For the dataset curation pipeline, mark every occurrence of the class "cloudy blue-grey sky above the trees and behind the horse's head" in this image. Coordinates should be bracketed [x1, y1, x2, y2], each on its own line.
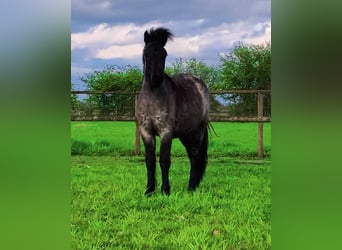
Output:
[71, 0, 271, 89]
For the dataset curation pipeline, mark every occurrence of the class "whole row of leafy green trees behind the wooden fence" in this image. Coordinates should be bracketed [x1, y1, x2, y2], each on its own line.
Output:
[71, 43, 271, 116]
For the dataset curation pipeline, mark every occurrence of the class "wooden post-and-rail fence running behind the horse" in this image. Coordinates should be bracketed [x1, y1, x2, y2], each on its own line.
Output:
[71, 90, 271, 158]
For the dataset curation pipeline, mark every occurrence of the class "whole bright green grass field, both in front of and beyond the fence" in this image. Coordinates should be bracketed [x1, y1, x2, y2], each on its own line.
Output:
[71, 122, 271, 249]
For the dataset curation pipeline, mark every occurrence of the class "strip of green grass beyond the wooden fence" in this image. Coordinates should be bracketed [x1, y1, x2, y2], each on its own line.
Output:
[71, 122, 271, 158]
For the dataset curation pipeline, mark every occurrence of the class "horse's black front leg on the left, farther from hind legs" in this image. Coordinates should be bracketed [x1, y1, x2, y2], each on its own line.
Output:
[142, 135, 156, 195]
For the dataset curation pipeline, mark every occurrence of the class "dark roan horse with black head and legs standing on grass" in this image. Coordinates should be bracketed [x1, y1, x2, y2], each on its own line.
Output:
[135, 28, 209, 195]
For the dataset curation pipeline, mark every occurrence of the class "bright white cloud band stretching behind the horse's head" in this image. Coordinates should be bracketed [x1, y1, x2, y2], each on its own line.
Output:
[71, 20, 271, 60]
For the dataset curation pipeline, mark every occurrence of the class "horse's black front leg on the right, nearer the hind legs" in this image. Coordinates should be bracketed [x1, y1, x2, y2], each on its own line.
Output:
[159, 135, 172, 195]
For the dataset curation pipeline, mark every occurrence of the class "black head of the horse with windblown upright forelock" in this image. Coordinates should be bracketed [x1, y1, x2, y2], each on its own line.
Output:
[143, 28, 173, 88]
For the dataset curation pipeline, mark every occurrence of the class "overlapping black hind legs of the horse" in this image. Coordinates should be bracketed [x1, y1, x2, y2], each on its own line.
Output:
[180, 129, 208, 191]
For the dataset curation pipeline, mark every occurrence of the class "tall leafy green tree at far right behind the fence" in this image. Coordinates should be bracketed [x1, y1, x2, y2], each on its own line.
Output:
[217, 43, 271, 116]
